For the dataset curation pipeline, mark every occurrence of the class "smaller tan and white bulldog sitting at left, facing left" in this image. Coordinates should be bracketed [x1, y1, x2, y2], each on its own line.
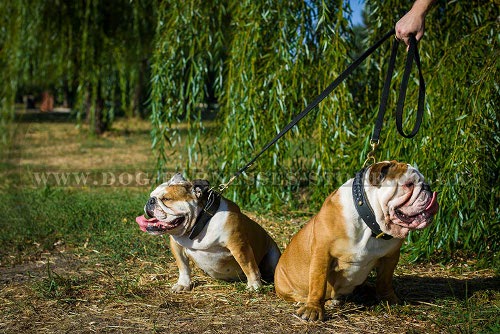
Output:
[136, 174, 281, 292]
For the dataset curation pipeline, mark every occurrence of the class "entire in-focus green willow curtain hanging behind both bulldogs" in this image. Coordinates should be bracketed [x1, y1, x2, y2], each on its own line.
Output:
[152, 0, 500, 258]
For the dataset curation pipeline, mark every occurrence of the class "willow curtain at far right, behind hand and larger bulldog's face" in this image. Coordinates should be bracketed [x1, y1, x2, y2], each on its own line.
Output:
[366, 0, 500, 260]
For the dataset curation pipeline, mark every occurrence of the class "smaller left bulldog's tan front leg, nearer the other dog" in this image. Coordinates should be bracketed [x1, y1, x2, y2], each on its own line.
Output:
[228, 242, 262, 290]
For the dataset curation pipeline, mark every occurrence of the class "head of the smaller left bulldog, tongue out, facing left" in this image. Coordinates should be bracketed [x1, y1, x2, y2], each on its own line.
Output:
[135, 173, 209, 235]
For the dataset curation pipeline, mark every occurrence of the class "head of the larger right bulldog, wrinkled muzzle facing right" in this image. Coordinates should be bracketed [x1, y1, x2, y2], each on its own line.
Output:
[365, 161, 439, 238]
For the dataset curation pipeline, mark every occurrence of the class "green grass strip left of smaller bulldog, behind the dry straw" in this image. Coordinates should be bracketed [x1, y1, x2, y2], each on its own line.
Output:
[0, 187, 170, 264]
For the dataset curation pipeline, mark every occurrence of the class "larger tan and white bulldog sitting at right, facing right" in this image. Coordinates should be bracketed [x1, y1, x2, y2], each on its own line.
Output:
[274, 161, 438, 321]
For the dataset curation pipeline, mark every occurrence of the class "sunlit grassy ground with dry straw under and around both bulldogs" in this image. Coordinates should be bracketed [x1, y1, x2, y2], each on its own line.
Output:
[0, 116, 500, 333]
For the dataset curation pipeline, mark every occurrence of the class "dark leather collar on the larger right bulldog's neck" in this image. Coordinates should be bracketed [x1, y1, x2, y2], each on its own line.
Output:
[352, 168, 392, 240]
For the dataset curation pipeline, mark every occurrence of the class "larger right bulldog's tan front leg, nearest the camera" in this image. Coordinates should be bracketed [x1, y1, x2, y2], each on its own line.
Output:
[297, 250, 331, 321]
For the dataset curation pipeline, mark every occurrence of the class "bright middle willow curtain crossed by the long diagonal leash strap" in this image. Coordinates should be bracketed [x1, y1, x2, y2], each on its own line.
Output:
[217, 1, 352, 208]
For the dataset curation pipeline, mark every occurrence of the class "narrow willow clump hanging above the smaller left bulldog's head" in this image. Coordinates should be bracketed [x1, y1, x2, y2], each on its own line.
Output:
[151, 0, 228, 175]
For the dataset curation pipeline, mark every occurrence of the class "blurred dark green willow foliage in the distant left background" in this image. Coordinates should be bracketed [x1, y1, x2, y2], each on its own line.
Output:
[0, 0, 157, 133]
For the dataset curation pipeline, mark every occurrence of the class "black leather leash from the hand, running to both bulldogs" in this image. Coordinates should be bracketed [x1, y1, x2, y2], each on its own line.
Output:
[218, 29, 425, 192]
